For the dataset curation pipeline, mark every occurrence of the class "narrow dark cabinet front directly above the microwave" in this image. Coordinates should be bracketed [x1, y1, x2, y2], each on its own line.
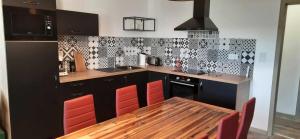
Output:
[3, 0, 56, 10]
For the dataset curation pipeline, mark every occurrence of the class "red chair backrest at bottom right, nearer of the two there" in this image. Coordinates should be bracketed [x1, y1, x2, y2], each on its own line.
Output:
[217, 112, 239, 139]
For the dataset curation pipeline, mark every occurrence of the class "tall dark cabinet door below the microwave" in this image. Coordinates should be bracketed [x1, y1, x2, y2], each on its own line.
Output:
[6, 42, 63, 139]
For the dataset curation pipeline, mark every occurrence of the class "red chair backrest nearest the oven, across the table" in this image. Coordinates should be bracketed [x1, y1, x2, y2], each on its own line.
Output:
[147, 80, 164, 106]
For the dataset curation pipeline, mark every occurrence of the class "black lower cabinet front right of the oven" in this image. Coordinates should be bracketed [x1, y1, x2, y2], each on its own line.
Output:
[199, 80, 237, 109]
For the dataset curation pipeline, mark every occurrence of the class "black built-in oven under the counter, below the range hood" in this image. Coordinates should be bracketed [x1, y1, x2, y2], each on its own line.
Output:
[169, 75, 199, 100]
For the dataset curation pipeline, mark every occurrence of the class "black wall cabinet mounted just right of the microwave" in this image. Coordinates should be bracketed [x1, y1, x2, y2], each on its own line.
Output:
[56, 10, 99, 36]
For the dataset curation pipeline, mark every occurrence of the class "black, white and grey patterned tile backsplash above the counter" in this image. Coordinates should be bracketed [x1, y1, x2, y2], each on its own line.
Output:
[58, 32, 256, 76]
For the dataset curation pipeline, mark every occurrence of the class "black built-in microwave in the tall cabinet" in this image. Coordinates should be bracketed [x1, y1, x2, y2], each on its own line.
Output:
[3, 6, 57, 41]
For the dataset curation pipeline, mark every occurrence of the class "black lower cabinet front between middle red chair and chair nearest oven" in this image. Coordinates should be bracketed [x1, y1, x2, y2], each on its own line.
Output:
[123, 72, 147, 107]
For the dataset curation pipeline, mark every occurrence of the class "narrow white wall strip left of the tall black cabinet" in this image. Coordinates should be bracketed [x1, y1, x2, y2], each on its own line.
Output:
[0, 1, 11, 139]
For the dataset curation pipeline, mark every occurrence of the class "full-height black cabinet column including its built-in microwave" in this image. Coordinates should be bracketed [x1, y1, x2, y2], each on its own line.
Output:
[3, 0, 63, 139]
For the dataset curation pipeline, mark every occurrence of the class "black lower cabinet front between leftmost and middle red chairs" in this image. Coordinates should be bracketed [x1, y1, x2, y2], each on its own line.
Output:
[92, 76, 124, 122]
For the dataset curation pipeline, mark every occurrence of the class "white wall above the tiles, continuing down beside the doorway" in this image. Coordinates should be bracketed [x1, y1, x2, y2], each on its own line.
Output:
[57, 0, 280, 130]
